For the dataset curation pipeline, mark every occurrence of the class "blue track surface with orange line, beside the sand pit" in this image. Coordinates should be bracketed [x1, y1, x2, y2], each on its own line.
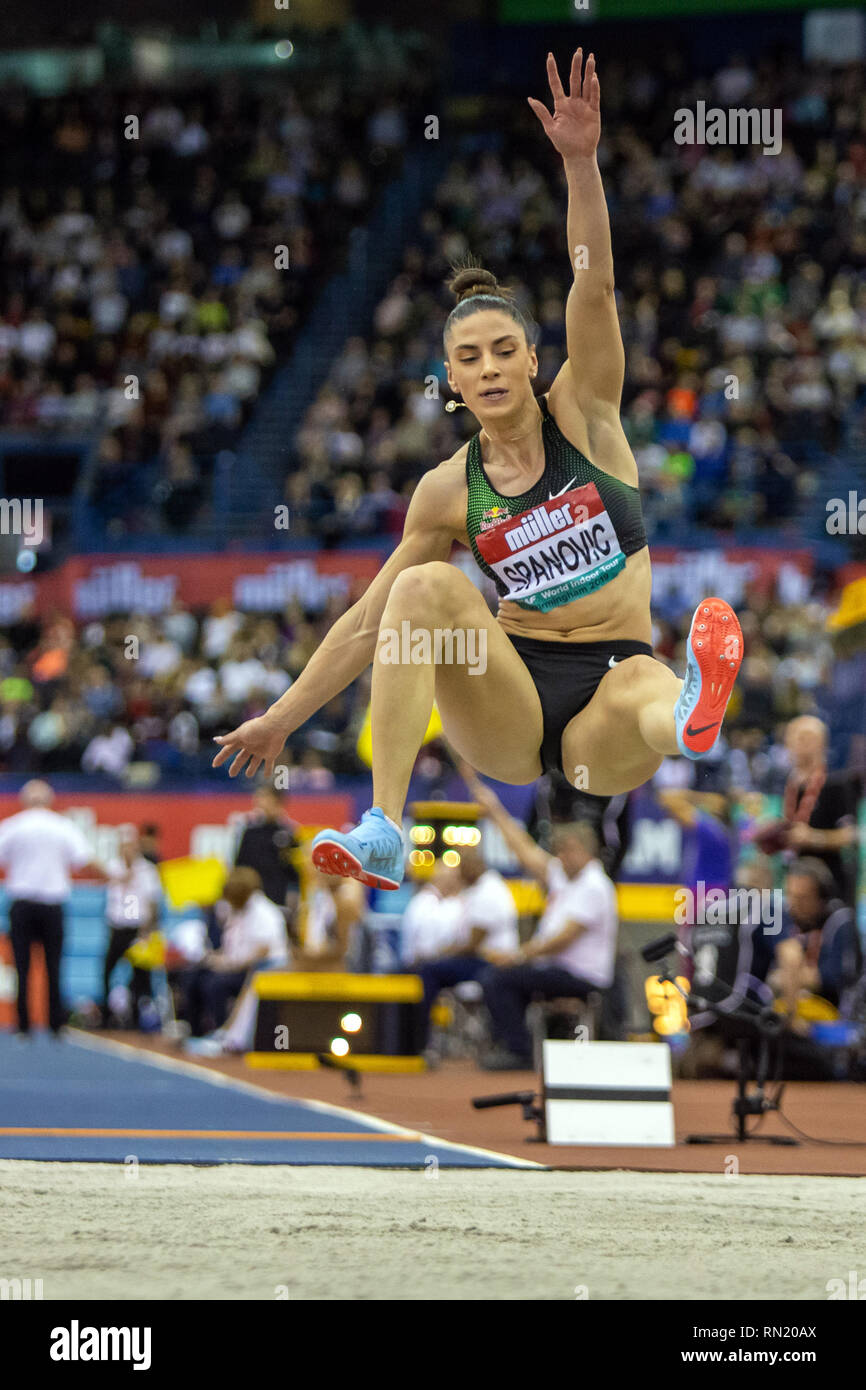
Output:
[0, 1034, 534, 1168]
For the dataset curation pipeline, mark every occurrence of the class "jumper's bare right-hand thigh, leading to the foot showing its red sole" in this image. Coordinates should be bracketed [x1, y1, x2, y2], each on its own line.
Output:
[560, 656, 678, 796]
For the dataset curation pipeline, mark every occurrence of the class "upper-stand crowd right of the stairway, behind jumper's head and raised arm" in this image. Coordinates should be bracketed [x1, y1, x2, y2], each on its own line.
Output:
[293, 51, 866, 542]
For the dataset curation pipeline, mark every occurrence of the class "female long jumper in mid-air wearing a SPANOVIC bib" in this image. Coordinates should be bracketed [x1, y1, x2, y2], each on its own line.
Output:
[214, 49, 742, 888]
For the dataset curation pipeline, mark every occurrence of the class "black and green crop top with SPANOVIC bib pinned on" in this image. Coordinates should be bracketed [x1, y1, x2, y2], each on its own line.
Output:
[466, 396, 646, 613]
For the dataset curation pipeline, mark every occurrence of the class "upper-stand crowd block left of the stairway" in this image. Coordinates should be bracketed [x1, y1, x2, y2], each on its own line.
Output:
[0, 27, 425, 537]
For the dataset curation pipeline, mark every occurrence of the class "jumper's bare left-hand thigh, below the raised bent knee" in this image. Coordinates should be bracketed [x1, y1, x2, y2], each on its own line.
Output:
[436, 575, 544, 783]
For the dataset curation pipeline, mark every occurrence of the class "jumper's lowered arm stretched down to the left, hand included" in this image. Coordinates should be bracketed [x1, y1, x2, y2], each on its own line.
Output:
[213, 466, 459, 777]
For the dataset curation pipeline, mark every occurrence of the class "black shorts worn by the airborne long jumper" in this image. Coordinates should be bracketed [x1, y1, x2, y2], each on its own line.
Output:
[506, 632, 652, 780]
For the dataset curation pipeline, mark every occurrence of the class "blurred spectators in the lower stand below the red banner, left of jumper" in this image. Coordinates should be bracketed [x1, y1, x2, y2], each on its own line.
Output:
[0, 600, 368, 791]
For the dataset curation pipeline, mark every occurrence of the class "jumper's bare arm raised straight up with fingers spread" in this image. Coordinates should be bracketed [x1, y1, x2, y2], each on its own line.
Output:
[528, 49, 626, 427]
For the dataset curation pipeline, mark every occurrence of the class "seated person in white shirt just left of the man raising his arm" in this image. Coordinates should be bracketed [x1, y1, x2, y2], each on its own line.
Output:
[417, 847, 518, 1045]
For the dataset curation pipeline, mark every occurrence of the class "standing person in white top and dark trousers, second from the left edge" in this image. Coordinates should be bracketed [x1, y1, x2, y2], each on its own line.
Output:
[101, 826, 163, 1027]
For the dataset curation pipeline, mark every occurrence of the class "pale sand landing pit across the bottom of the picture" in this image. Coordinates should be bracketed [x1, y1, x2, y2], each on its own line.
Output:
[0, 1161, 866, 1301]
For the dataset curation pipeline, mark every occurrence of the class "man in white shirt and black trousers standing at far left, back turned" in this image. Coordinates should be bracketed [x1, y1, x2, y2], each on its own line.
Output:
[0, 781, 104, 1037]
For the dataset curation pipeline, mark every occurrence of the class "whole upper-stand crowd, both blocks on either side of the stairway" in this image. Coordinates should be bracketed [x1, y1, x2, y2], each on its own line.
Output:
[0, 36, 866, 545]
